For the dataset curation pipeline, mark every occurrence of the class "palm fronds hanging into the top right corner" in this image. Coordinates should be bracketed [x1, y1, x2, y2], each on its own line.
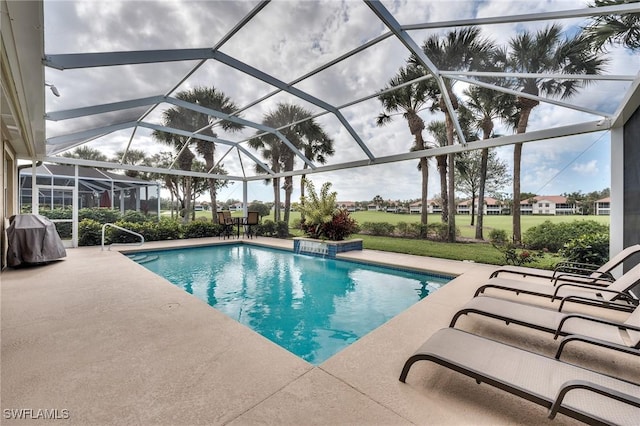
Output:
[583, 0, 640, 50]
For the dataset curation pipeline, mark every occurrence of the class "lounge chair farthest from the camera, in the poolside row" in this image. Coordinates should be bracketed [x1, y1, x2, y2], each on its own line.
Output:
[489, 244, 640, 284]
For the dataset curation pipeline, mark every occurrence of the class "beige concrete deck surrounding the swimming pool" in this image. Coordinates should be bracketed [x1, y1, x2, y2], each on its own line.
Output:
[0, 237, 640, 425]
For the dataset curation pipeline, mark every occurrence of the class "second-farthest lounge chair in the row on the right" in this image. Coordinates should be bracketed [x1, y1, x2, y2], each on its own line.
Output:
[474, 264, 640, 310]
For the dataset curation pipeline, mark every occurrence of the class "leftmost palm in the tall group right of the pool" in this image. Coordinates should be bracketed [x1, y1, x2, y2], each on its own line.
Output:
[376, 65, 435, 225]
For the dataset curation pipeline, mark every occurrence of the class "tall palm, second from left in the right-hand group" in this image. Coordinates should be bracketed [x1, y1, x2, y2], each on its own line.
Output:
[409, 27, 494, 242]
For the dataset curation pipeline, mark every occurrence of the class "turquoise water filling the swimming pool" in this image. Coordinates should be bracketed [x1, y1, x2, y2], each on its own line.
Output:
[130, 245, 450, 365]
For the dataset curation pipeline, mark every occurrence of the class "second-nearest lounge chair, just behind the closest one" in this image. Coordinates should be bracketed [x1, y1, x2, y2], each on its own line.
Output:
[449, 296, 640, 349]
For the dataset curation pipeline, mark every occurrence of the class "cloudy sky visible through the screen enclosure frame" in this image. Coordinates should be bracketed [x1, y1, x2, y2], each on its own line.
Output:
[44, 0, 640, 201]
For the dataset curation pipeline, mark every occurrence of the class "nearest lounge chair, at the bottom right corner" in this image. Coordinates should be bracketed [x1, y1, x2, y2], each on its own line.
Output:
[400, 328, 640, 425]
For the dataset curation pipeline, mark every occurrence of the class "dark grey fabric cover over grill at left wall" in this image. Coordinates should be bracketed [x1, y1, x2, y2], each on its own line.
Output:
[7, 214, 67, 266]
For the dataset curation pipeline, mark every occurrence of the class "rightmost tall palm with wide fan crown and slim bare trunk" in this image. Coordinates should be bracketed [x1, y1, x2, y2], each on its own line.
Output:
[502, 25, 606, 244]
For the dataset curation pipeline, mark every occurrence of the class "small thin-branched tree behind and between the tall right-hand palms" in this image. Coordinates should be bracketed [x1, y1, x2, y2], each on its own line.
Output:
[456, 150, 511, 226]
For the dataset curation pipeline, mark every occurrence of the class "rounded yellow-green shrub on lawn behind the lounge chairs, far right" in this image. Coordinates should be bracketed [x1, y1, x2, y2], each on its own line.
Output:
[523, 220, 609, 252]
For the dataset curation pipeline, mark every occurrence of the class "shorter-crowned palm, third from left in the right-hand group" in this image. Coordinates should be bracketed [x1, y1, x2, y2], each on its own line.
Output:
[463, 86, 516, 240]
